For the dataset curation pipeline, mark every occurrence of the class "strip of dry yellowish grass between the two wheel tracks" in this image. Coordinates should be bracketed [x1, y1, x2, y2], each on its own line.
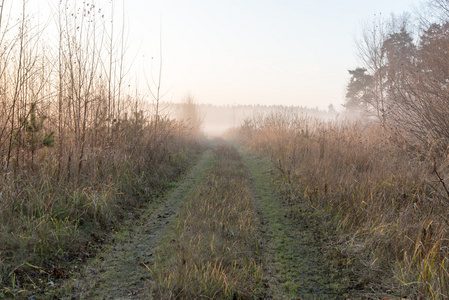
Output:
[148, 146, 262, 299]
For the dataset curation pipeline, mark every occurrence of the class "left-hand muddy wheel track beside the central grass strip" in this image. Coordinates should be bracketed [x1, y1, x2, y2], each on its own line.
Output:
[58, 150, 211, 299]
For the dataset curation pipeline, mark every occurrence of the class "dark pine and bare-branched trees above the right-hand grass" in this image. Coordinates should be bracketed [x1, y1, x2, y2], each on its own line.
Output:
[344, 0, 449, 156]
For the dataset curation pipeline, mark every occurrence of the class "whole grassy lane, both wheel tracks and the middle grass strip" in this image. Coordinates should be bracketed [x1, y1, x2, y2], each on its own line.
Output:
[56, 145, 356, 299]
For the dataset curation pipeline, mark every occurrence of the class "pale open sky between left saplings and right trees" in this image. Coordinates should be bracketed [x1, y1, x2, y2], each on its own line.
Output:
[14, 0, 416, 109]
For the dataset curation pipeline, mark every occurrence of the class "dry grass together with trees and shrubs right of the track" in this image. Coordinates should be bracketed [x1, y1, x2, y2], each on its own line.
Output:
[239, 0, 449, 299]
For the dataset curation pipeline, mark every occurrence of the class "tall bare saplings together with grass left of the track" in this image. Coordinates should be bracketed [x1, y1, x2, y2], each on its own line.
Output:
[0, 0, 199, 298]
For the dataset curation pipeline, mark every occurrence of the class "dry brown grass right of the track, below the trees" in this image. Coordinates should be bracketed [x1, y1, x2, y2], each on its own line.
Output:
[240, 113, 449, 299]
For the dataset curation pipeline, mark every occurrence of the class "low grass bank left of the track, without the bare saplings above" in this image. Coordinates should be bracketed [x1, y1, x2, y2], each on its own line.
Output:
[0, 120, 198, 298]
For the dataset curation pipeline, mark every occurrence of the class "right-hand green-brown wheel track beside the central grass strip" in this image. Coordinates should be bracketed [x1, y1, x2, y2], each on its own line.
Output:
[241, 152, 351, 299]
